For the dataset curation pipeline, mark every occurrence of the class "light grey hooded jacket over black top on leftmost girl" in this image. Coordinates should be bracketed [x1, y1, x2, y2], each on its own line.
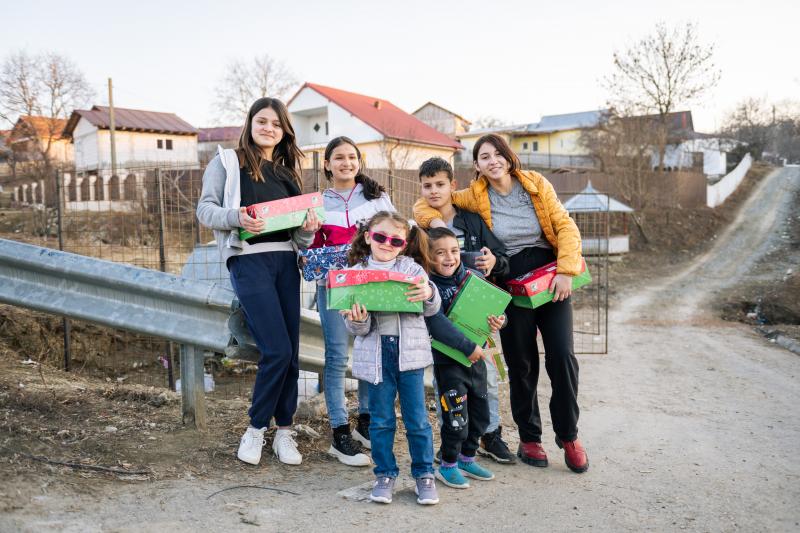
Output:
[197, 147, 314, 264]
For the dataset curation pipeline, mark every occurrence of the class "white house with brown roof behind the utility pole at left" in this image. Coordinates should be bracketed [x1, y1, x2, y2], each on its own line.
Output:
[64, 106, 198, 172]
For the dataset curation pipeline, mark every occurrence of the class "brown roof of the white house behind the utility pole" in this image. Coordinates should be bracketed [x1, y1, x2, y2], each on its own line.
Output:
[64, 105, 197, 137]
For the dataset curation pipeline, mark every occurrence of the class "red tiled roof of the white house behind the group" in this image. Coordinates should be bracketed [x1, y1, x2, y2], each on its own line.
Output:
[287, 82, 463, 150]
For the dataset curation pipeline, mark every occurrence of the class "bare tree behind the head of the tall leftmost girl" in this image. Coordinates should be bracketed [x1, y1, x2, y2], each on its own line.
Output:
[214, 54, 298, 124]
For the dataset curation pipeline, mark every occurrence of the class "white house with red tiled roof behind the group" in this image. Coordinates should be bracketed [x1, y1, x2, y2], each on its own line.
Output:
[287, 83, 461, 169]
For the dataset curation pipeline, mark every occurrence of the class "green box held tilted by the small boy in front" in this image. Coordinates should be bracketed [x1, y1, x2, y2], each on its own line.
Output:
[431, 272, 511, 366]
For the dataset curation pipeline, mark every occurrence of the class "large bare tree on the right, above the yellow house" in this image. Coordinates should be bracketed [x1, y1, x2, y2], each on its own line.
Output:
[604, 23, 720, 165]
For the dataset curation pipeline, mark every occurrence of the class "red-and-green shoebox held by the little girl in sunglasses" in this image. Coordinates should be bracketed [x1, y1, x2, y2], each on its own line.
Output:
[327, 270, 422, 313]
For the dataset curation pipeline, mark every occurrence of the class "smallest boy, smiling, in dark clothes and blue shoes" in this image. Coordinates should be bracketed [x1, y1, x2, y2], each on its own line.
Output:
[425, 228, 505, 489]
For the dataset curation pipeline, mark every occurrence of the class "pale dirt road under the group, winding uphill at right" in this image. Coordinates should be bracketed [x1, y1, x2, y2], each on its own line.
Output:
[0, 169, 800, 531]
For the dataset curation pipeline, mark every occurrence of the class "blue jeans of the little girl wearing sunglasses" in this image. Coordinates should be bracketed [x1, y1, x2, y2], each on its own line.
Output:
[369, 336, 433, 478]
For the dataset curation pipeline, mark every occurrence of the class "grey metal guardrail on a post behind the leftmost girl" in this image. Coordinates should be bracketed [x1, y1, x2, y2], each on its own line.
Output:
[0, 239, 332, 429]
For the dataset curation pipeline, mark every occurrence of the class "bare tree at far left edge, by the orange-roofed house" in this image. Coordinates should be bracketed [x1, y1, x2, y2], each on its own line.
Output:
[0, 50, 94, 172]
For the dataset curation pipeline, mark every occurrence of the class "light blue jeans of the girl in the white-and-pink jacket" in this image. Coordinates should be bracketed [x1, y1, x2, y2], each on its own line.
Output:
[317, 285, 369, 428]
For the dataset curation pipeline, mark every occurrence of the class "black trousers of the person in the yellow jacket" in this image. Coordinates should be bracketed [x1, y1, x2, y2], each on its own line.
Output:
[500, 247, 580, 442]
